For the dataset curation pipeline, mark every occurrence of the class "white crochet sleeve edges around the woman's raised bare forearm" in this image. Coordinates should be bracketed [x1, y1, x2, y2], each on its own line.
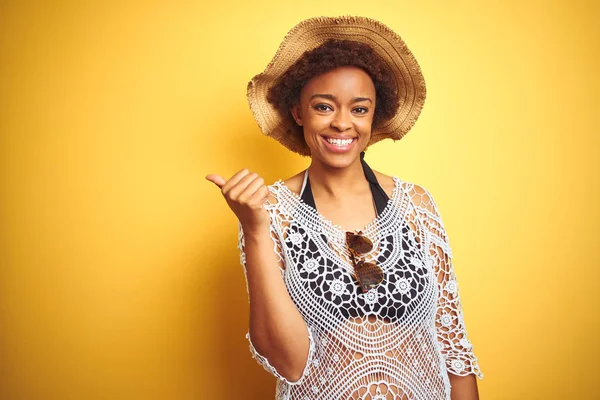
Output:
[238, 217, 315, 385]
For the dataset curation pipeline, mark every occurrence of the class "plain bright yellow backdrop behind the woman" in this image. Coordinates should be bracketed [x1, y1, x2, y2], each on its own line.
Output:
[0, 0, 600, 400]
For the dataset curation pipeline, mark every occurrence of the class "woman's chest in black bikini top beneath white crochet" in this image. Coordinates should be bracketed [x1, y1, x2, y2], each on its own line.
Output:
[282, 221, 437, 323]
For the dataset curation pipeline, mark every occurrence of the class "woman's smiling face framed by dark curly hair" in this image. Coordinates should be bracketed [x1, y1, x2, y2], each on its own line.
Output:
[291, 66, 375, 168]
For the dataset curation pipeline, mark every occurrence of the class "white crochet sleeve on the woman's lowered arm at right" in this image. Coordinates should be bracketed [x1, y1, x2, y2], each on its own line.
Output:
[415, 185, 483, 379]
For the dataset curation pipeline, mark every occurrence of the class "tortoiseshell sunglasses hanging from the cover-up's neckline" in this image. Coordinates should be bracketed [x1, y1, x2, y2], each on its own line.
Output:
[346, 231, 383, 293]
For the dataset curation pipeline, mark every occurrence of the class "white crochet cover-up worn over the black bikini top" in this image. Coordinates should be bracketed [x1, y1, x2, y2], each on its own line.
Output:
[238, 177, 483, 400]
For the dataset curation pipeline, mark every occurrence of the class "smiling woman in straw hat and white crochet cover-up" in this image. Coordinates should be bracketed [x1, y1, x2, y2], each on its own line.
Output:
[207, 17, 483, 400]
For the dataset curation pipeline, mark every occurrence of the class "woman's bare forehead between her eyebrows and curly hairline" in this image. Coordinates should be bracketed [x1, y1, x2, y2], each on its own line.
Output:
[300, 66, 375, 99]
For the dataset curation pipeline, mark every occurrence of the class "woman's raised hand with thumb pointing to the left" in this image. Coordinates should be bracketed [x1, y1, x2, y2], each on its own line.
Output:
[206, 168, 271, 234]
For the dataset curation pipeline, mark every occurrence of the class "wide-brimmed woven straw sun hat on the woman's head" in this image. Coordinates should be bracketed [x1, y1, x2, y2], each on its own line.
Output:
[247, 16, 426, 156]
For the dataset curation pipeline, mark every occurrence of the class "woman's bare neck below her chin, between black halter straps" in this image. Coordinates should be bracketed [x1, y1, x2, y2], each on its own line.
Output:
[308, 157, 369, 198]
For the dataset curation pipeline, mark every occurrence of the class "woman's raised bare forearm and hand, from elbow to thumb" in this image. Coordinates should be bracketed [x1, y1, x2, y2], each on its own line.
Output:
[206, 169, 309, 381]
